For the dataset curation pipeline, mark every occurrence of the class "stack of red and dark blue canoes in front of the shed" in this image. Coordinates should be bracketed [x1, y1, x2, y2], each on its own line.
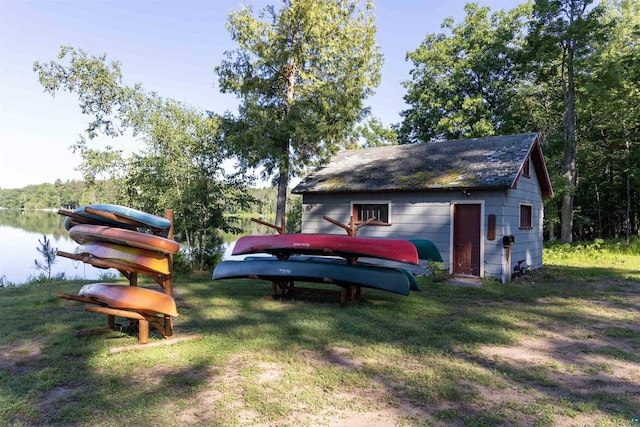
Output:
[213, 234, 441, 302]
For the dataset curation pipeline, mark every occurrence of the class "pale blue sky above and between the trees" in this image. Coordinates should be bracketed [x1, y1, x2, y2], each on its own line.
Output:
[0, 0, 524, 189]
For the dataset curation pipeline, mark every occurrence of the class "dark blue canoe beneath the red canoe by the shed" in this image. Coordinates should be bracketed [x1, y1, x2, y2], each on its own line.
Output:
[213, 258, 410, 296]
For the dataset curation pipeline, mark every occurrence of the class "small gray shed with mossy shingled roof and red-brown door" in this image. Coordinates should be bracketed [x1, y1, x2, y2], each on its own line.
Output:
[293, 133, 553, 281]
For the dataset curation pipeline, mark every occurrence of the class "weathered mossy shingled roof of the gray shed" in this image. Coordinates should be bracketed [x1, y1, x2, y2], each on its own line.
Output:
[293, 133, 553, 197]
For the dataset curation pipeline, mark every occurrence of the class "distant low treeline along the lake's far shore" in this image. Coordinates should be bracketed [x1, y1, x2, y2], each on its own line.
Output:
[0, 180, 277, 218]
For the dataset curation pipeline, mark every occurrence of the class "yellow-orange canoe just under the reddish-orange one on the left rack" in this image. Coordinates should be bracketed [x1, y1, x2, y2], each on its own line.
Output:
[75, 242, 170, 274]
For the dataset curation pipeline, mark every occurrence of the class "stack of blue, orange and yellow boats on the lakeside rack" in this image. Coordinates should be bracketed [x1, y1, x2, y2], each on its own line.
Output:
[58, 205, 180, 342]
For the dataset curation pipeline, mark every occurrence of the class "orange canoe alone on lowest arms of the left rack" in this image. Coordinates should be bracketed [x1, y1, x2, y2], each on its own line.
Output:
[78, 283, 178, 316]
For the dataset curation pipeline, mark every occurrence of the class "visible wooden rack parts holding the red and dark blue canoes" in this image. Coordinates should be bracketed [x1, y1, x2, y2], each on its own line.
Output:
[246, 215, 376, 307]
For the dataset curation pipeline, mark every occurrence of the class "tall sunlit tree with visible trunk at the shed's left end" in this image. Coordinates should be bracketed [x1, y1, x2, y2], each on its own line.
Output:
[215, 0, 382, 224]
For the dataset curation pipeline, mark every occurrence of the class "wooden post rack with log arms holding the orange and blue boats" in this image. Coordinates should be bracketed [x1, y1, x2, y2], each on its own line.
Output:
[57, 207, 190, 353]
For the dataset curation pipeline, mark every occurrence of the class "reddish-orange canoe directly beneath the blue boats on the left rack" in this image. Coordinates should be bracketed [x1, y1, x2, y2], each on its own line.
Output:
[69, 224, 180, 254]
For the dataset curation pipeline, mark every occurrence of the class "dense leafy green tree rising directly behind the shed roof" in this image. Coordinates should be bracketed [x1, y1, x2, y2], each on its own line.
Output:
[397, 3, 530, 143]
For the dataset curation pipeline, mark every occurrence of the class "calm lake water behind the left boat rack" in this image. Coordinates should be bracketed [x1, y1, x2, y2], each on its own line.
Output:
[0, 209, 119, 285]
